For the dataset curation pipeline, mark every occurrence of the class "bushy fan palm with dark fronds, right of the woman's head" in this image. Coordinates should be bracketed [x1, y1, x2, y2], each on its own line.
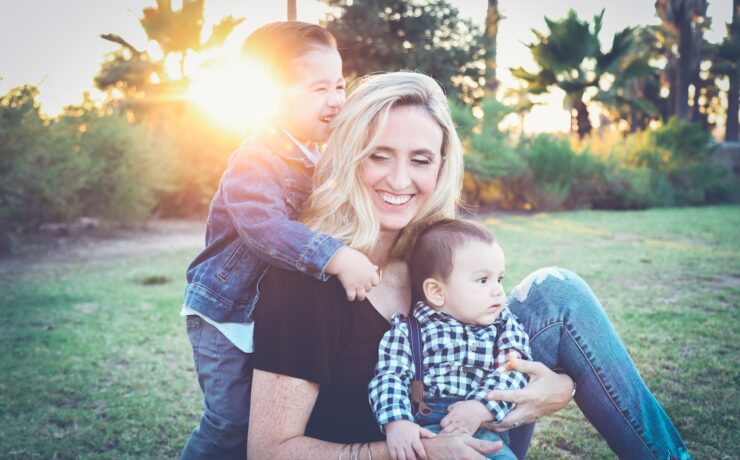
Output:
[512, 9, 633, 137]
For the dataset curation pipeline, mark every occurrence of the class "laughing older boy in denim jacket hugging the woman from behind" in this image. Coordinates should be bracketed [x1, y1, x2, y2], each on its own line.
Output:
[182, 22, 379, 458]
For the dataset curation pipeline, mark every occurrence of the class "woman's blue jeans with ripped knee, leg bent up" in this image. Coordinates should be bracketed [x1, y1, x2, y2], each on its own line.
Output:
[509, 268, 690, 459]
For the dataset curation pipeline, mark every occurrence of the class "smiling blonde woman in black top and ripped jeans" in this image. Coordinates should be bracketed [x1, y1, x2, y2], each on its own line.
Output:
[248, 72, 687, 459]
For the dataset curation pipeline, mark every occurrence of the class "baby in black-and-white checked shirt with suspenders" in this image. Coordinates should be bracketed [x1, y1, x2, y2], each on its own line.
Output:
[369, 219, 532, 459]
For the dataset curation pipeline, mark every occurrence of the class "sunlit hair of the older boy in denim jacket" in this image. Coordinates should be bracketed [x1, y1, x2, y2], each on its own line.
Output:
[242, 21, 337, 81]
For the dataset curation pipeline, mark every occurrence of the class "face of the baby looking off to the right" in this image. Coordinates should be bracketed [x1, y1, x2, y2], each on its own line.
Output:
[440, 240, 506, 326]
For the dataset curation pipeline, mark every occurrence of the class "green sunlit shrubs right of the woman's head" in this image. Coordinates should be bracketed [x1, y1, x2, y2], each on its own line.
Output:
[460, 100, 740, 210]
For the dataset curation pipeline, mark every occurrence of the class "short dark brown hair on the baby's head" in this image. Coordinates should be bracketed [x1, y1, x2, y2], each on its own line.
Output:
[409, 219, 496, 300]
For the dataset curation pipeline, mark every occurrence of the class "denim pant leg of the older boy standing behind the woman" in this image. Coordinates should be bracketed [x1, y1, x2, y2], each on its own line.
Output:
[180, 315, 253, 460]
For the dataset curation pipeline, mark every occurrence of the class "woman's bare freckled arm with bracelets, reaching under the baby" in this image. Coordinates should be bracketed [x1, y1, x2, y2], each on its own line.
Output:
[247, 369, 501, 460]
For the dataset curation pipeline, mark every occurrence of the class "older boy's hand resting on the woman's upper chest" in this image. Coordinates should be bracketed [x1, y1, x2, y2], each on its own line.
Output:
[326, 246, 380, 302]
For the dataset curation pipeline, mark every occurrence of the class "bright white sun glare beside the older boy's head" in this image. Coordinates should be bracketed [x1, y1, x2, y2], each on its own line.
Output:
[188, 59, 279, 132]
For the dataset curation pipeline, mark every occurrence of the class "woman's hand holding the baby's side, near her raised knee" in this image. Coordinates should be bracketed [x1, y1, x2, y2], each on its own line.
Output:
[483, 359, 575, 432]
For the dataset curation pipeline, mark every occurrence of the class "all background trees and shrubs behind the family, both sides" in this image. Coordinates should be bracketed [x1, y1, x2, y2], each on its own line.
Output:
[0, 0, 740, 252]
